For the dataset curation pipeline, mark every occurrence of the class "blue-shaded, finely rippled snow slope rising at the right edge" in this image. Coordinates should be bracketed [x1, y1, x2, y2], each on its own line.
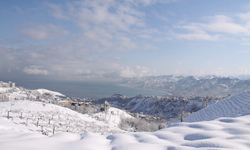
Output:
[184, 90, 250, 122]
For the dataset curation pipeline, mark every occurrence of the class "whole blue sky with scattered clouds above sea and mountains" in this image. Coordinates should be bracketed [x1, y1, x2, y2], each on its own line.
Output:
[0, 0, 250, 81]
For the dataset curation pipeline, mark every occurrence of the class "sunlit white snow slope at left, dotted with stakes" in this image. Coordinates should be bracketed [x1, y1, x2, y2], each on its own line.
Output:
[0, 100, 124, 135]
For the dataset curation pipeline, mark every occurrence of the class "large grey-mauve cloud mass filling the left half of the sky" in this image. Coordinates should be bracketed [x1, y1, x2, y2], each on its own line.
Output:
[0, 0, 177, 80]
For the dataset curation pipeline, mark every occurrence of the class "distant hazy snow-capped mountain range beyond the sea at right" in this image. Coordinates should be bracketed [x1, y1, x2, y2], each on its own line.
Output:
[122, 75, 250, 97]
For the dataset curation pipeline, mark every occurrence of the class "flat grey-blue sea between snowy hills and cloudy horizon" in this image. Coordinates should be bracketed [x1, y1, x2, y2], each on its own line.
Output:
[13, 81, 165, 98]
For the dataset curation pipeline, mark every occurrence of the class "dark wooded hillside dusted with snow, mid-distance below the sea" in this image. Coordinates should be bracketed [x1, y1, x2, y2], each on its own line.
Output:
[93, 96, 221, 120]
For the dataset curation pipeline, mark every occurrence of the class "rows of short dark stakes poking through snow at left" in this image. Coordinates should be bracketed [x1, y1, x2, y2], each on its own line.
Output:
[1, 105, 122, 135]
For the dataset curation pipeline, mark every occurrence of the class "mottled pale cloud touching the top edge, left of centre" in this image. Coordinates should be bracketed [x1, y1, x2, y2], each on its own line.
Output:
[47, 0, 145, 31]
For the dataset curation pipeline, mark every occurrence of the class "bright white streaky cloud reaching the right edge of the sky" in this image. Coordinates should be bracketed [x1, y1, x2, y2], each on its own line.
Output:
[171, 15, 250, 41]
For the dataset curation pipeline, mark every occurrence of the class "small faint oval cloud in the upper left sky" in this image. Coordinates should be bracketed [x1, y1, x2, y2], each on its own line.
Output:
[20, 24, 69, 40]
